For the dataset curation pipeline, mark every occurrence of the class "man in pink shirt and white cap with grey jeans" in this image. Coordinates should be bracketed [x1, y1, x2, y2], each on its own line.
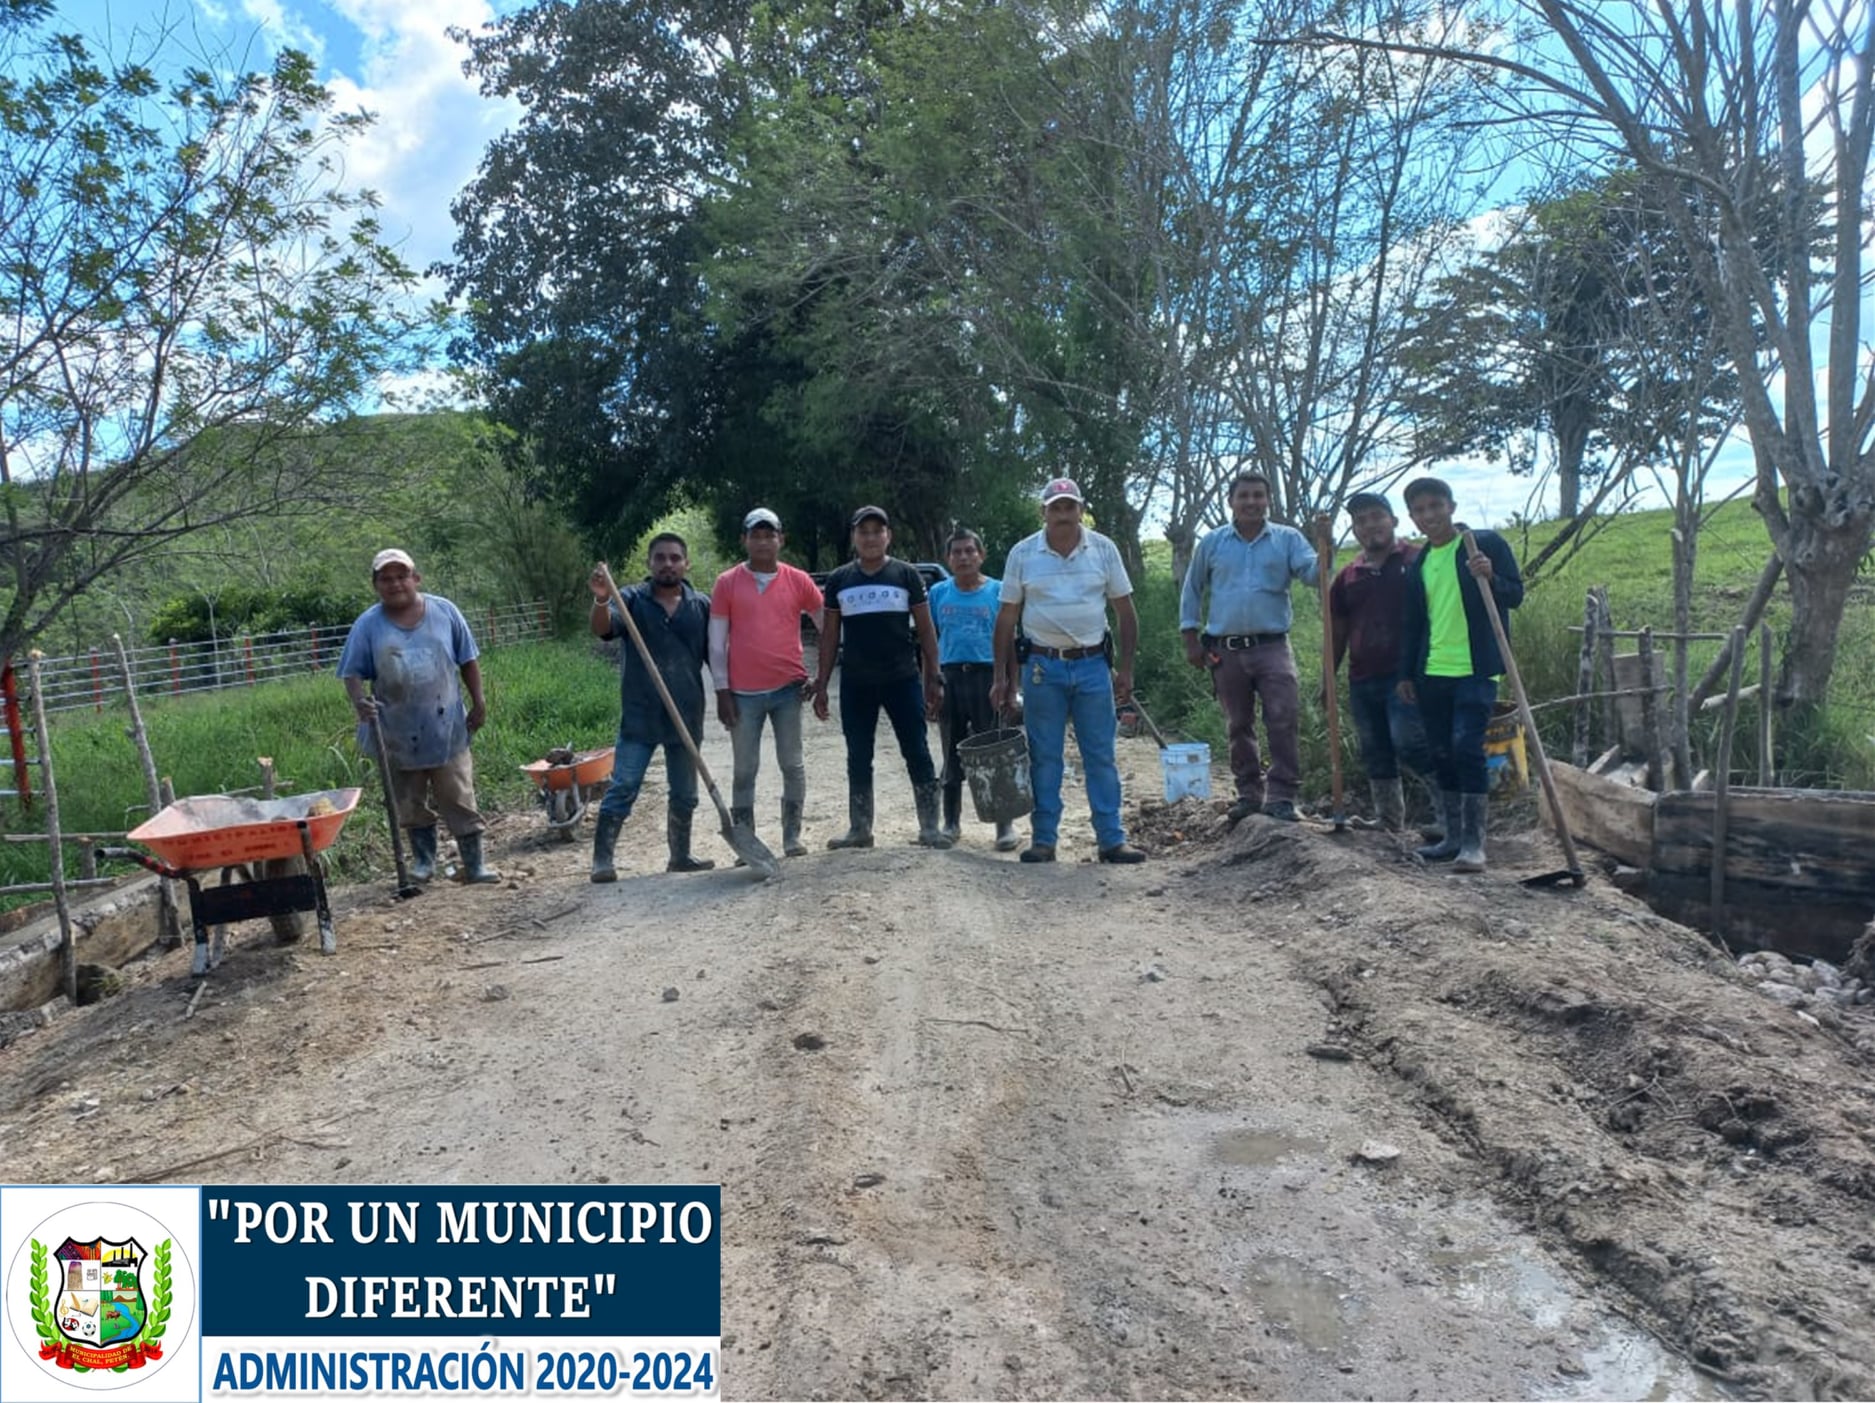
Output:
[709, 506, 823, 857]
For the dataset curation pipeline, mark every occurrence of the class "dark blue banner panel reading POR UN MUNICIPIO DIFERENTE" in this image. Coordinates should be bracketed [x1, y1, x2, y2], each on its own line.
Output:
[201, 1184, 722, 1337]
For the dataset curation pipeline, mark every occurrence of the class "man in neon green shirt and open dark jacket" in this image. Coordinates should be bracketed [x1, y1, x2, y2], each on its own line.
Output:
[1401, 478, 1523, 872]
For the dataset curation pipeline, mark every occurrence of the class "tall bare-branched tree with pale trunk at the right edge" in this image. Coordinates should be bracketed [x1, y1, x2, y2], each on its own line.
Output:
[1331, 0, 1875, 707]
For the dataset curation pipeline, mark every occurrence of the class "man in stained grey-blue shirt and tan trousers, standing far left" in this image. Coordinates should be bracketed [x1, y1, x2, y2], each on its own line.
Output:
[339, 550, 501, 882]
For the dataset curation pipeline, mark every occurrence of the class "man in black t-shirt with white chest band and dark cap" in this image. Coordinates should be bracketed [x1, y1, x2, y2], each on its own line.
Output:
[814, 506, 951, 848]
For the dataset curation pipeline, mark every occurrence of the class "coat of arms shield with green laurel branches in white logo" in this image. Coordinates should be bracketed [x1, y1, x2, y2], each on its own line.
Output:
[32, 1238, 174, 1373]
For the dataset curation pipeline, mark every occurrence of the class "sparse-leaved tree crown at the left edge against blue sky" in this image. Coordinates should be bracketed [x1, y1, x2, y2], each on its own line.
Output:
[0, 0, 420, 656]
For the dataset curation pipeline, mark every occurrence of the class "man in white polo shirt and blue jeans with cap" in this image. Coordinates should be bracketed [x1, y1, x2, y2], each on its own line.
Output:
[990, 478, 1146, 863]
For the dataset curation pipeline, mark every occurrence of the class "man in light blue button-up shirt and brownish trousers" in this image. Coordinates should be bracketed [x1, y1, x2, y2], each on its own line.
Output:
[1179, 473, 1320, 827]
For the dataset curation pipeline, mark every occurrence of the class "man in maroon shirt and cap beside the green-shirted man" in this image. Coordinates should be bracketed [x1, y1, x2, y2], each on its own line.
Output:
[1328, 491, 1433, 829]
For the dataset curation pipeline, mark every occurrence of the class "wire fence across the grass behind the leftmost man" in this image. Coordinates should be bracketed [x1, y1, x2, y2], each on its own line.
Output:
[23, 600, 553, 713]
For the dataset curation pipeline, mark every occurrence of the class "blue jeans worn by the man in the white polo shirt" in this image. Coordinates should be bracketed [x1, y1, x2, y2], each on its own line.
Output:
[1022, 656, 1127, 852]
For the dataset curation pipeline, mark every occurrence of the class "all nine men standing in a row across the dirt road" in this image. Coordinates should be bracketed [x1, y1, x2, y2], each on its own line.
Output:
[339, 473, 1523, 882]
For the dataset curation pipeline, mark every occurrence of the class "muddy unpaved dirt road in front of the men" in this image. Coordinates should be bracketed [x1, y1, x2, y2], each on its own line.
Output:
[0, 701, 1875, 1397]
